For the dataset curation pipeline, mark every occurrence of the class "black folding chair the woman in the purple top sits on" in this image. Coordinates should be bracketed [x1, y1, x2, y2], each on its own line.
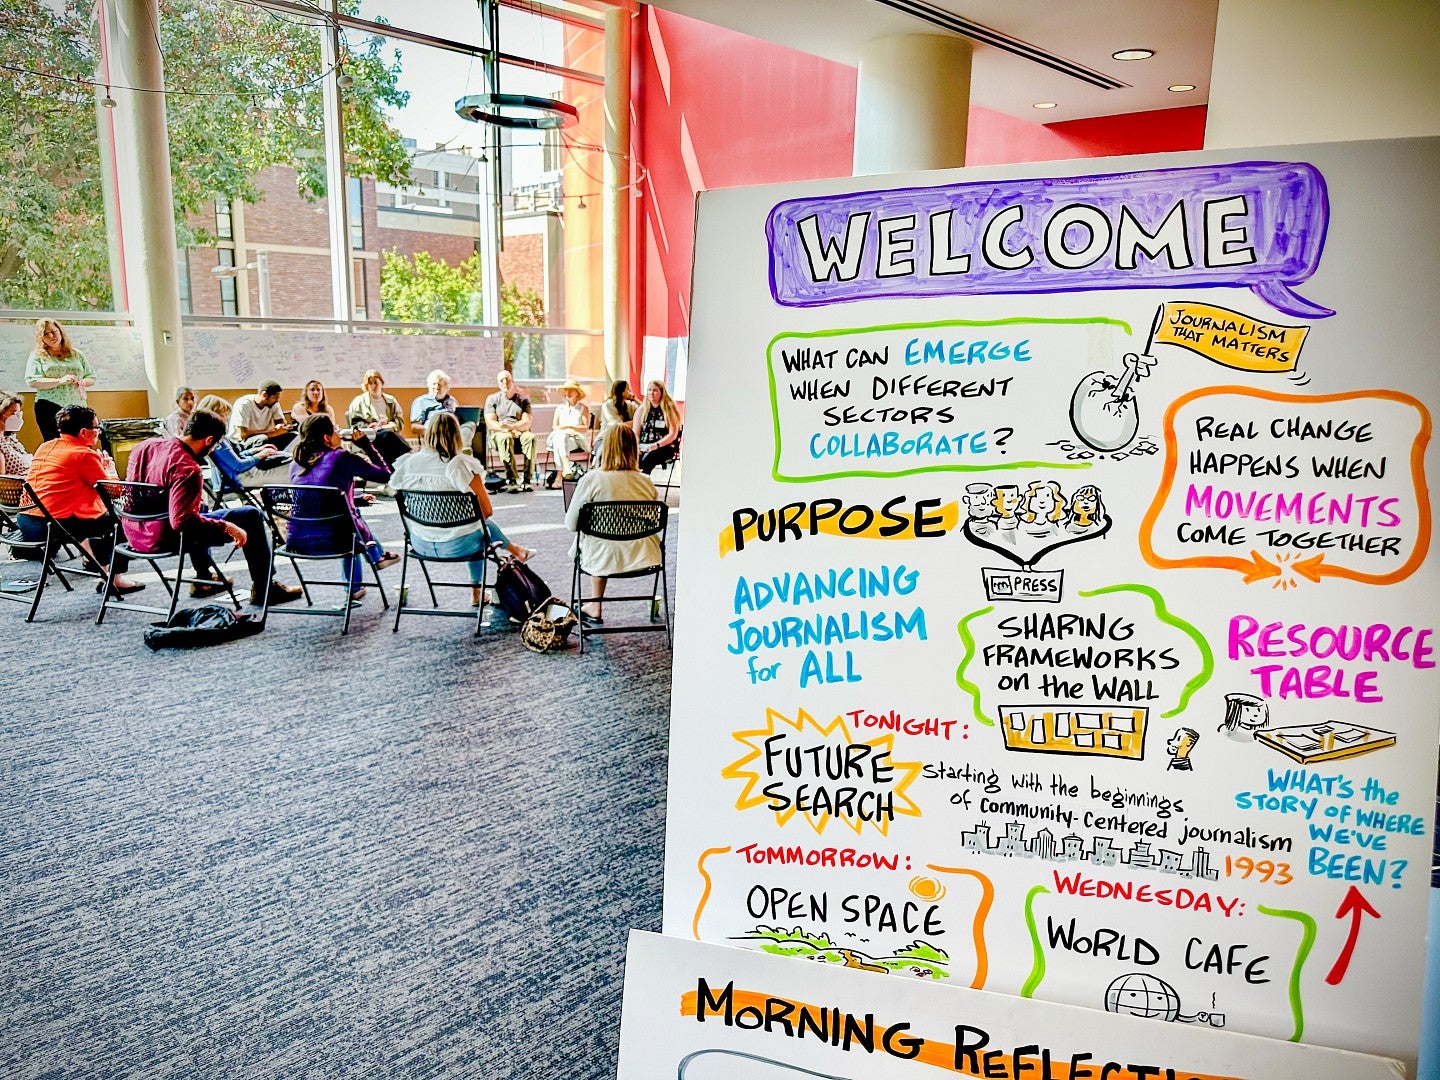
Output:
[261, 484, 390, 635]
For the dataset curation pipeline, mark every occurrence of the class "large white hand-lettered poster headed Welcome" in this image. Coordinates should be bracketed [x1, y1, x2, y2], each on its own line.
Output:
[664, 133, 1440, 1064]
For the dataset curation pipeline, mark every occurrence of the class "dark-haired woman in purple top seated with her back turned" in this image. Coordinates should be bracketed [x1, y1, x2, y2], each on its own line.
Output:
[287, 413, 400, 599]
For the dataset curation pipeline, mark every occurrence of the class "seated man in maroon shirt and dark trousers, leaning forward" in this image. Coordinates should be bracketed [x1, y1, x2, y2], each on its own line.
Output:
[125, 409, 301, 605]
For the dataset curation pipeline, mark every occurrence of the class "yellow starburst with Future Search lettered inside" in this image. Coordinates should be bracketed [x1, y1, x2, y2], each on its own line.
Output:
[720, 708, 922, 835]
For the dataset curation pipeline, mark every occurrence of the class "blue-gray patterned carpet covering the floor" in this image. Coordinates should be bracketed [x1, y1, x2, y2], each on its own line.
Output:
[0, 492, 675, 1080]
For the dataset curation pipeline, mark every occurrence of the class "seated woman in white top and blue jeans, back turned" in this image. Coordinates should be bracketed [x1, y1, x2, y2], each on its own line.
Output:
[390, 412, 534, 608]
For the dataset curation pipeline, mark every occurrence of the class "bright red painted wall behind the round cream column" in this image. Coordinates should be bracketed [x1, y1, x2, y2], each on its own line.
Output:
[631, 6, 1205, 368]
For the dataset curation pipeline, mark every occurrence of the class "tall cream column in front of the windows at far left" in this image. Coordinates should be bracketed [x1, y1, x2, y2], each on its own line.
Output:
[101, 0, 186, 416]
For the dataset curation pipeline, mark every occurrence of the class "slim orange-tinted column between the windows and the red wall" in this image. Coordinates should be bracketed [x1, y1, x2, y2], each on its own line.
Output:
[602, 7, 634, 382]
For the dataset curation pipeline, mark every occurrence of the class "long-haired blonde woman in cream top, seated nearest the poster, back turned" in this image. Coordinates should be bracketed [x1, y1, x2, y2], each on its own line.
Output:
[564, 423, 661, 625]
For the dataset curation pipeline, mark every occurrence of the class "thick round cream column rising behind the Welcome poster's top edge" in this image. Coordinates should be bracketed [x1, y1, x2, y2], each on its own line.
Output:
[854, 35, 971, 176]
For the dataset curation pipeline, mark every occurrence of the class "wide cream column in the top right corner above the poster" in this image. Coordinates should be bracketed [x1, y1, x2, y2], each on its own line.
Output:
[1205, 0, 1440, 150]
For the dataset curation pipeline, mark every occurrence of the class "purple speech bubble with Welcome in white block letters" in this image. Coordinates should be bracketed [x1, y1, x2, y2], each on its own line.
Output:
[765, 161, 1335, 318]
